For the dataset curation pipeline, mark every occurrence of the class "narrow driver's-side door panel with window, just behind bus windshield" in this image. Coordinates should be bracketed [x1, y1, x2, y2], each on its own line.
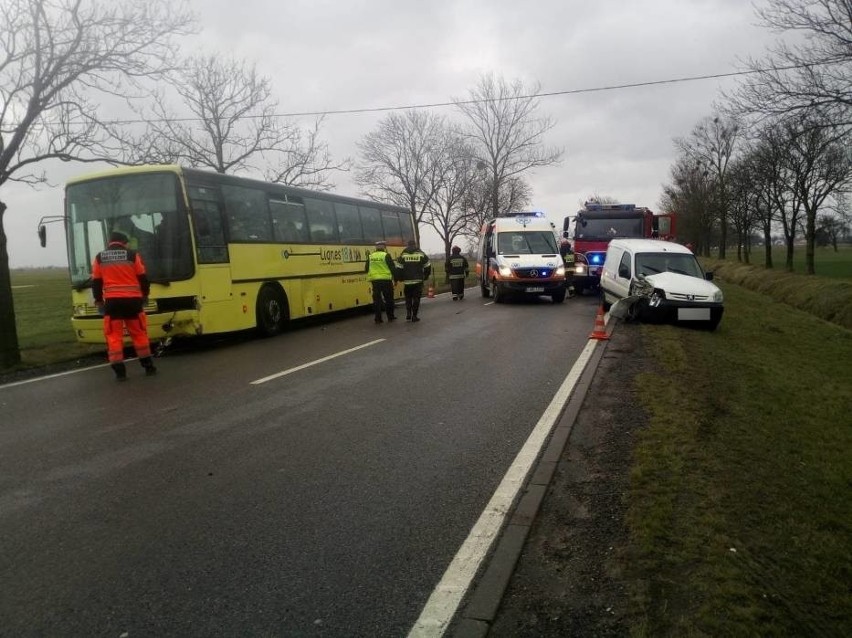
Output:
[189, 185, 232, 308]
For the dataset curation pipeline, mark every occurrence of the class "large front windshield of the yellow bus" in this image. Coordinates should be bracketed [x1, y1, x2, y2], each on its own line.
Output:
[65, 172, 193, 286]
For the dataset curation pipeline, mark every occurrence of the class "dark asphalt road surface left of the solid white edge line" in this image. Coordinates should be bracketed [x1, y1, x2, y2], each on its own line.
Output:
[0, 290, 597, 637]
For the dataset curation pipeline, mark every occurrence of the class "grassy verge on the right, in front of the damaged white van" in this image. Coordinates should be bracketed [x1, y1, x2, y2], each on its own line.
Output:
[628, 286, 852, 636]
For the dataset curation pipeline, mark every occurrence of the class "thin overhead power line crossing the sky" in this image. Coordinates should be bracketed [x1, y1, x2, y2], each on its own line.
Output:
[103, 62, 836, 124]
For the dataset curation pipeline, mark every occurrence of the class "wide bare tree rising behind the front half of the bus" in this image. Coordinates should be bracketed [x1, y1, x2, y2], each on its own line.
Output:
[129, 55, 349, 190]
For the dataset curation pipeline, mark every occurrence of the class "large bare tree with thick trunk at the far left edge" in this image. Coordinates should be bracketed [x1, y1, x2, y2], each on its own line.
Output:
[0, 0, 193, 368]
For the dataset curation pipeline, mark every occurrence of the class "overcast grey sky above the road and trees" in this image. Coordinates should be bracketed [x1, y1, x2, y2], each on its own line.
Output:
[2, 0, 777, 268]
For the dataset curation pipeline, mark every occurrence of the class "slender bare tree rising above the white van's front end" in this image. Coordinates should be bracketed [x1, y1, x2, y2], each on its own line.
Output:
[675, 115, 741, 259]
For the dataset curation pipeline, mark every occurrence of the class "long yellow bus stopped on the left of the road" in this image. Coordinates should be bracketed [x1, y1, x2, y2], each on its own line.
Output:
[45, 165, 415, 343]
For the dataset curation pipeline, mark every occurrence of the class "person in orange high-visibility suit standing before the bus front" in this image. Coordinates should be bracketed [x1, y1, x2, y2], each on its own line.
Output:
[92, 232, 157, 381]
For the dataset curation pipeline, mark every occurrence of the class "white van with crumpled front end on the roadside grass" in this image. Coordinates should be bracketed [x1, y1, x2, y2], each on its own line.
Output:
[601, 239, 724, 330]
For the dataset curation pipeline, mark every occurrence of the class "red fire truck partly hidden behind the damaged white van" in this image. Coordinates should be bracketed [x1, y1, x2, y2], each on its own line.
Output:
[562, 202, 675, 295]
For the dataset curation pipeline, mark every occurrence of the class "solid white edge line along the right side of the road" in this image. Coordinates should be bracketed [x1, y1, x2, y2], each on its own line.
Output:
[408, 341, 598, 638]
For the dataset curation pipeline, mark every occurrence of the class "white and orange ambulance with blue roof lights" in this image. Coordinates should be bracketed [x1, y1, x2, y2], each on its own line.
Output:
[476, 212, 566, 303]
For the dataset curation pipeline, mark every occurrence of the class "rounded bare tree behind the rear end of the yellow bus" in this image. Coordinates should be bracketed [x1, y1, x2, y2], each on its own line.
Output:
[356, 110, 446, 241]
